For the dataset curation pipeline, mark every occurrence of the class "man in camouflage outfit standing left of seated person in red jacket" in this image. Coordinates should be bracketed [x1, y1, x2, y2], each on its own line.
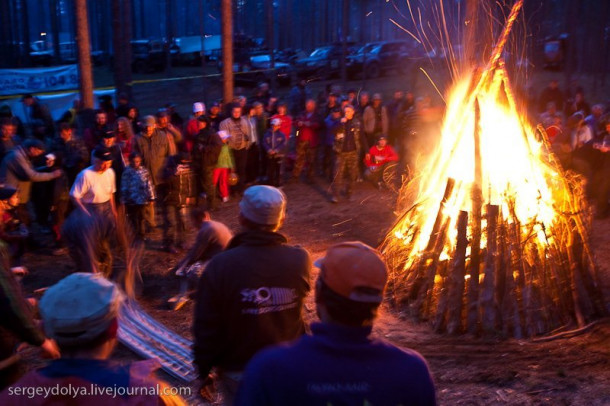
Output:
[330, 105, 367, 203]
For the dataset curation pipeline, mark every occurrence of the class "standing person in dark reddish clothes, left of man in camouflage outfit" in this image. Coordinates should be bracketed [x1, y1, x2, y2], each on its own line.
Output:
[292, 99, 322, 183]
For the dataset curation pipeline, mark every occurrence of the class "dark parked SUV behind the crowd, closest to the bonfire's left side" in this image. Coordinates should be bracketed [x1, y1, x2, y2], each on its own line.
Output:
[347, 41, 422, 79]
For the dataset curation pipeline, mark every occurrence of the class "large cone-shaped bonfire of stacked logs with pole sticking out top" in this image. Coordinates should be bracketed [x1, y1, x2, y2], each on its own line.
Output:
[381, 2, 606, 338]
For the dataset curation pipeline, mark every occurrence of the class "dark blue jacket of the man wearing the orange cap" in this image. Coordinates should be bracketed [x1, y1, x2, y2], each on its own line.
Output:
[235, 323, 436, 406]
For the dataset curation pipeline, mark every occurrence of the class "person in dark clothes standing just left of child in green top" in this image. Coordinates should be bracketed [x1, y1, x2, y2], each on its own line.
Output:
[193, 116, 223, 210]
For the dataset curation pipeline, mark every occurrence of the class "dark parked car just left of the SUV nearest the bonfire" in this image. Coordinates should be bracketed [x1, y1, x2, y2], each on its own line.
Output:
[295, 43, 355, 79]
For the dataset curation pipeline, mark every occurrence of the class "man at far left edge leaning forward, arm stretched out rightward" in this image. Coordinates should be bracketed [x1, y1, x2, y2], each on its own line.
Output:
[0, 139, 62, 226]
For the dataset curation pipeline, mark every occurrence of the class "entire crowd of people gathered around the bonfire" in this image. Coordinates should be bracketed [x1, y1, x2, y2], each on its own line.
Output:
[0, 75, 610, 405]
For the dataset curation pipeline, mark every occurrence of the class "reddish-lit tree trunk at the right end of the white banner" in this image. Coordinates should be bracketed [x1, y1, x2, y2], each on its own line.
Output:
[74, 0, 93, 109]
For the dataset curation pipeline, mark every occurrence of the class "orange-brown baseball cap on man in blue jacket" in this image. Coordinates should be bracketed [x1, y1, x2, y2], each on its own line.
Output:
[315, 241, 388, 303]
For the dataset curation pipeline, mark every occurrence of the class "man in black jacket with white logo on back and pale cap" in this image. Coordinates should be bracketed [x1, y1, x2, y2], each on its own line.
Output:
[193, 186, 311, 404]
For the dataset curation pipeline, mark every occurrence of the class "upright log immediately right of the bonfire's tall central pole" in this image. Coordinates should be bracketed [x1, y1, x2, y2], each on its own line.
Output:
[480, 205, 499, 331]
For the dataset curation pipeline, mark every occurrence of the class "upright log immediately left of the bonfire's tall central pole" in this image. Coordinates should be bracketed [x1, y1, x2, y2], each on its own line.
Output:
[447, 211, 468, 334]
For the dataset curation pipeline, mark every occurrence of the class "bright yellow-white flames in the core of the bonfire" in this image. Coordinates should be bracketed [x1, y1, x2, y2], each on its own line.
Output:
[394, 71, 558, 268]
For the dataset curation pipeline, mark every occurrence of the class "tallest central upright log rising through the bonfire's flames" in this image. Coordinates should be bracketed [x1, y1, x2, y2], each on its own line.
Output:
[466, 99, 483, 334]
